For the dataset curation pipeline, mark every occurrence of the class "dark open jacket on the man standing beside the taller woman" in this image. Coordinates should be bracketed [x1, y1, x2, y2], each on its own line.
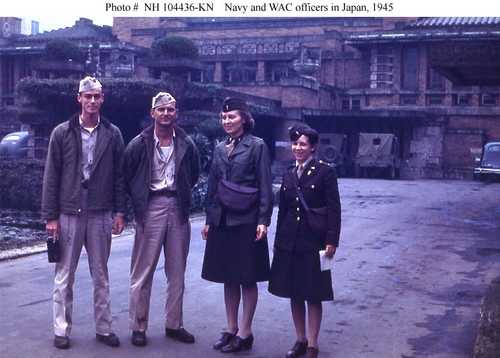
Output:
[123, 124, 200, 220]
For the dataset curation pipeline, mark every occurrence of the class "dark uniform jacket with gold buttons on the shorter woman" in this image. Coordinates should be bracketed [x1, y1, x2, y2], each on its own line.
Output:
[274, 159, 340, 252]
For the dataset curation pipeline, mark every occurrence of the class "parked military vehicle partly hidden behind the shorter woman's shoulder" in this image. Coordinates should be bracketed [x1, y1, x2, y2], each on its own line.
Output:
[318, 133, 350, 176]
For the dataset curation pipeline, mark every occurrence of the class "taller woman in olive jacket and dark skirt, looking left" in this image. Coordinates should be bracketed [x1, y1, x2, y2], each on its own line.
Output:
[201, 98, 273, 353]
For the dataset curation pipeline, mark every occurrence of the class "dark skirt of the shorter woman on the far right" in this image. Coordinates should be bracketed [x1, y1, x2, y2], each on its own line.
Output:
[269, 249, 333, 303]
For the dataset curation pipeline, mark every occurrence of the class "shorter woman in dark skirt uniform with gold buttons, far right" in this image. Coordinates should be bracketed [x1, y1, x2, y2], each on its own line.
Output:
[269, 125, 340, 358]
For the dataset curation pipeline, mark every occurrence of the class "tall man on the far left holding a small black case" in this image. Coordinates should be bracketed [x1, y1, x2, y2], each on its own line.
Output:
[42, 77, 125, 349]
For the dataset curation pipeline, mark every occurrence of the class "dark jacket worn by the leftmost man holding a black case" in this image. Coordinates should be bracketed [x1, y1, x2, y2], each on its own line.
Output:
[42, 113, 125, 220]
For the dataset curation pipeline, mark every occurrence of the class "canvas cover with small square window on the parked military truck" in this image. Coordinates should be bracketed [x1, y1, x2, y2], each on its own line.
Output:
[356, 133, 395, 167]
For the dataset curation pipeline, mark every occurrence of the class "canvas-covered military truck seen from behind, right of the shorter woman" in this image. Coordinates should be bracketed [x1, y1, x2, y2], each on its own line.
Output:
[354, 133, 401, 179]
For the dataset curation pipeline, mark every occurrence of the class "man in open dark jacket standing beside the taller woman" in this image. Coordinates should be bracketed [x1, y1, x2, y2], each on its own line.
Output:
[124, 92, 199, 346]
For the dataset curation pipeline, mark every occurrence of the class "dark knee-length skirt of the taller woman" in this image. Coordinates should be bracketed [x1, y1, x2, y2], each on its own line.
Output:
[201, 224, 270, 285]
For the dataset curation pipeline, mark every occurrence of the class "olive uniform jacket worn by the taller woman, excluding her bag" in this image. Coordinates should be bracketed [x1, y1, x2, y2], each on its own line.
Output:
[206, 134, 273, 226]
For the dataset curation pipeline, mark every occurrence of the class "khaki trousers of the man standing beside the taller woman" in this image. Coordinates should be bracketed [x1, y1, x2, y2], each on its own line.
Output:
[129, 195, 191, 331]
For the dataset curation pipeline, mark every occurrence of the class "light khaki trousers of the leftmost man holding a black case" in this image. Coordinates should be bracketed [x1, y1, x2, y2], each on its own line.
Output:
[53, 190, 112, 336]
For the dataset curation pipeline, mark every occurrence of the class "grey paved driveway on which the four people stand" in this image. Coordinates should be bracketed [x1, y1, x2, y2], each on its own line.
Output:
[0, 179, 500, 358]
